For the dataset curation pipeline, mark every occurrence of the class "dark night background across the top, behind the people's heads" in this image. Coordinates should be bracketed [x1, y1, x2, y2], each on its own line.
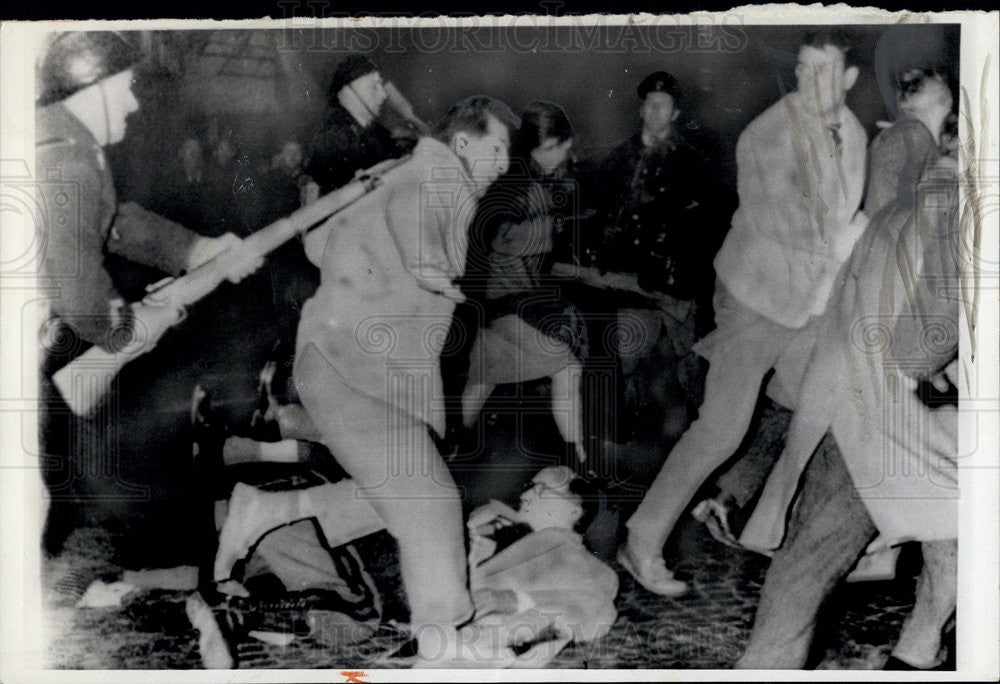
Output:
[119, 21, 959, 207]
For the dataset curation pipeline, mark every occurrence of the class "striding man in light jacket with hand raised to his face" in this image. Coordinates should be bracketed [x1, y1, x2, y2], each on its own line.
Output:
[619, 31, 866, 595]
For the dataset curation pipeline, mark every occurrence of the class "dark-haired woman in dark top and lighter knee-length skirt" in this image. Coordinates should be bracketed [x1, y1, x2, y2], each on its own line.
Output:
[462, 102, 587, 462]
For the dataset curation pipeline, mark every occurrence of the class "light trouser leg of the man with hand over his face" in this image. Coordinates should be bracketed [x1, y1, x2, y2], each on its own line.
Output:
[628, 326, 781, 557]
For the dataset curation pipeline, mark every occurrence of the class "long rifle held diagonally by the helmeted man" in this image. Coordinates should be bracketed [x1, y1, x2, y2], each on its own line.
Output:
[52, 156, 409, 416]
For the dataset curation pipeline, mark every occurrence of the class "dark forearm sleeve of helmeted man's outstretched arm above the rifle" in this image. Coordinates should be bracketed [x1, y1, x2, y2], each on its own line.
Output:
[107, 202, 199, 275]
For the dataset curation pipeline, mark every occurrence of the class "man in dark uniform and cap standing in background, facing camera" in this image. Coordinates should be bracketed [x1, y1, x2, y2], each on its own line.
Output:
[598, 71, 729, 436]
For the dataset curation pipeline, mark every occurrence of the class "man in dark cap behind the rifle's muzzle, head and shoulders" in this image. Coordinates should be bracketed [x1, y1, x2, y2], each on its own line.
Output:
[306, 55, 405, 194]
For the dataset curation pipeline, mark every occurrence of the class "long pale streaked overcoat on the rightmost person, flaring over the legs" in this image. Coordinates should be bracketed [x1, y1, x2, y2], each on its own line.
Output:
[741, 119, 959, 549]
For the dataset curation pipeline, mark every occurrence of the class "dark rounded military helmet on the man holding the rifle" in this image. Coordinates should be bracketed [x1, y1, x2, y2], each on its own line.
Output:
[37, 31, 143, 105]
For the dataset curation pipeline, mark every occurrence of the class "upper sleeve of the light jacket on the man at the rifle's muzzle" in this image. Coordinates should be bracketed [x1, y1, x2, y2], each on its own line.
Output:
[386, 183, 464, 295]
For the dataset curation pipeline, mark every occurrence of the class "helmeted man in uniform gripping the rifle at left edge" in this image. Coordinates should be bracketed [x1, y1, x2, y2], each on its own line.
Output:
[35, 31, 260, 551]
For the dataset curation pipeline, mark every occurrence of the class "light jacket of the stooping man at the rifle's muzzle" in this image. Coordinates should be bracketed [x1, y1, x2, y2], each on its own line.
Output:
[296, 138, 477, 434]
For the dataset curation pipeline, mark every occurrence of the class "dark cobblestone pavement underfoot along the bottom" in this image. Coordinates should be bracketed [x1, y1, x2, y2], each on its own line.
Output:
[43, 398, 936, 669]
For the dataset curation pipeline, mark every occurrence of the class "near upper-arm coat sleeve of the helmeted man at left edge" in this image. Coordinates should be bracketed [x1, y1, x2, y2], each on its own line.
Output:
[38, 150, 126, 349]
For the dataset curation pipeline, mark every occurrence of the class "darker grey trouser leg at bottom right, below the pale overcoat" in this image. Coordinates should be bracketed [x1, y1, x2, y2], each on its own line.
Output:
[736, 436, 876, 669]
